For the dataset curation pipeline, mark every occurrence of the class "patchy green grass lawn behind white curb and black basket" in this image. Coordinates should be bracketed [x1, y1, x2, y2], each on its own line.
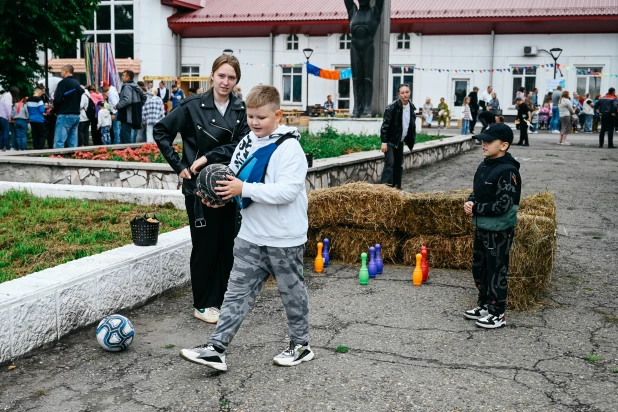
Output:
[0, 190, 189, 282]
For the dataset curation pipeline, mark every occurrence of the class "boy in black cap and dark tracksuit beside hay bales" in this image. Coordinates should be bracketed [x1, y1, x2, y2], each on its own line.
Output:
[464, 123, 521, 329]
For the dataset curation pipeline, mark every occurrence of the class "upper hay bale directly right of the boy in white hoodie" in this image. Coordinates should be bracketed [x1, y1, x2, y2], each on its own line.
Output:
[308, 182, 404, 232]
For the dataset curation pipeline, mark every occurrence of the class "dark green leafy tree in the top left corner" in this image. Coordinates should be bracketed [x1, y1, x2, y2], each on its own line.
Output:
[0, 0, 99, 93]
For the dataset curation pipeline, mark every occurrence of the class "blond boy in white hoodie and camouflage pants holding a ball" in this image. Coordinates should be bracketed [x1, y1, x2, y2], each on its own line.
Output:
[180, 86, 315, 371]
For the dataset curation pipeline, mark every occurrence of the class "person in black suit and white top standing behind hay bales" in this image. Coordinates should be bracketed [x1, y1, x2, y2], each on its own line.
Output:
[380, 84, 416, 189]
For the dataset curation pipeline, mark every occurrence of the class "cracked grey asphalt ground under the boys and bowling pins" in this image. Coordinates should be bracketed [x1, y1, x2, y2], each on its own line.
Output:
[0, 134, 618, 411]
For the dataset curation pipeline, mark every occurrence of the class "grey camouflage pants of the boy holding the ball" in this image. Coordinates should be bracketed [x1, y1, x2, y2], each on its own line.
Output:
[209, 237, 309, 349]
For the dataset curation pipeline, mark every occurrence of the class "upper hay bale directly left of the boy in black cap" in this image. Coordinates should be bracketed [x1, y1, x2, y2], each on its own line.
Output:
[400, 189, 474, 236]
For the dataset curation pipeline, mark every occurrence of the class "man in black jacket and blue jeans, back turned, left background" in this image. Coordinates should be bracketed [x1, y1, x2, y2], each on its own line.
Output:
[53, 64, 84, 149]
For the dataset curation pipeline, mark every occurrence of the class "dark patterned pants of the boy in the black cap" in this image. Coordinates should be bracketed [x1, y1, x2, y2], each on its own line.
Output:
[472, 228, 514, 315]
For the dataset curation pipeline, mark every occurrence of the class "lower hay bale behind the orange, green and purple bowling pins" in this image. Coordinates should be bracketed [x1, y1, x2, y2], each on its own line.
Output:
[305, 226, 401, 264]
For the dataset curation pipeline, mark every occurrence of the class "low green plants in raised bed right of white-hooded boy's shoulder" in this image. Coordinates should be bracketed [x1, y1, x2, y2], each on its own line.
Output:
[300, 127, 445, 159]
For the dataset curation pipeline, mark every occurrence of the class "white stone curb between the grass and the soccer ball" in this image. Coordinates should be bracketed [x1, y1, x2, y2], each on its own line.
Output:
[0, 227, 191, 363]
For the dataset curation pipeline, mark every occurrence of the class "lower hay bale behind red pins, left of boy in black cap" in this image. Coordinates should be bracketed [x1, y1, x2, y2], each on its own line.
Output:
[402, 236, 474, 270]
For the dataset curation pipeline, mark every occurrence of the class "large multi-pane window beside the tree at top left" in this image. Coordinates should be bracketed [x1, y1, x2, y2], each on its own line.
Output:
[76, 0, 135, 59]
